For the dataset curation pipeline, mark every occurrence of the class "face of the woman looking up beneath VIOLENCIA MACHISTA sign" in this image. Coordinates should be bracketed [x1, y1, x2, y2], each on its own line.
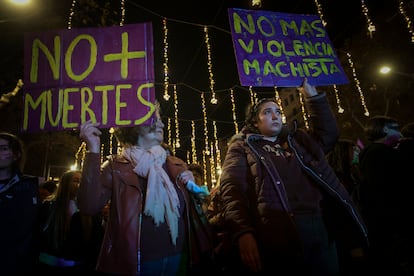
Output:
[254, 102, 283, 137]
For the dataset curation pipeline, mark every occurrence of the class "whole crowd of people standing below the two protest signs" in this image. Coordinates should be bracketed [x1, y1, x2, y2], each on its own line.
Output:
[0, 79, 414, 276]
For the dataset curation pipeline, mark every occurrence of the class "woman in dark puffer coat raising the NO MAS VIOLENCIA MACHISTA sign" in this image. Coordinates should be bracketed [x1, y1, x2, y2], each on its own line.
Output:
[220, 79, 367, 275]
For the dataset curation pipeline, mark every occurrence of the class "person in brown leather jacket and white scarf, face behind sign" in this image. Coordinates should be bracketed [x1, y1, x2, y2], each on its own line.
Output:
[78, 104, 212, 275]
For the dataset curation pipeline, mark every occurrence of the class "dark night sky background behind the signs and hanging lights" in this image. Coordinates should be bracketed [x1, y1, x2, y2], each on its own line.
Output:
[0, 0, 414, 180]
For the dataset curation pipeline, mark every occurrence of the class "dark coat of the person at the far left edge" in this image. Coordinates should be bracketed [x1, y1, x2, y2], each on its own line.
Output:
[0, 173, 39, 275]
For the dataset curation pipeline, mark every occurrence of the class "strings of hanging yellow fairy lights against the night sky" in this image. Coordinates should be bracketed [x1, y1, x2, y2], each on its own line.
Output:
[67, 0, 414, 172]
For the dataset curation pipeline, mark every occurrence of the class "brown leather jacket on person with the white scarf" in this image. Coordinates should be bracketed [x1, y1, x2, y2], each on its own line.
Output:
[78, 153, 207, 275]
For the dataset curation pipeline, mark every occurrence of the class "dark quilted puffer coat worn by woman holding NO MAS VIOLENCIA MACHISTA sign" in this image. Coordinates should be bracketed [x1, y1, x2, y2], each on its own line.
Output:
[220, 94, 367, 255]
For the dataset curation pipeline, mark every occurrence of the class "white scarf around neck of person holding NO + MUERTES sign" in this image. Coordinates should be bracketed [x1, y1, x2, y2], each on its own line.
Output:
[122, 146, 180, 245]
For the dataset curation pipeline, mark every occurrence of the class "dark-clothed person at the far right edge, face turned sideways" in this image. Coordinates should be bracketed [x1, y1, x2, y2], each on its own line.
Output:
[359, 116, 412, 275]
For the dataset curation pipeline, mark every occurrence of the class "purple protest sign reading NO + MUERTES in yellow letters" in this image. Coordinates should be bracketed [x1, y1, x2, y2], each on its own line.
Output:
[22, 23, 155, 132]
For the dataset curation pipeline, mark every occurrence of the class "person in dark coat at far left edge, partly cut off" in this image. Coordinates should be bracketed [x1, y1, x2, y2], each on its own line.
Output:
[0, 132, 40, 275]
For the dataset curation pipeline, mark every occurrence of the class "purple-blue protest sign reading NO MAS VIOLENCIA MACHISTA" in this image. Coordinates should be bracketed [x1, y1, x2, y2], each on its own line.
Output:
[228, 8, 349, 87]
